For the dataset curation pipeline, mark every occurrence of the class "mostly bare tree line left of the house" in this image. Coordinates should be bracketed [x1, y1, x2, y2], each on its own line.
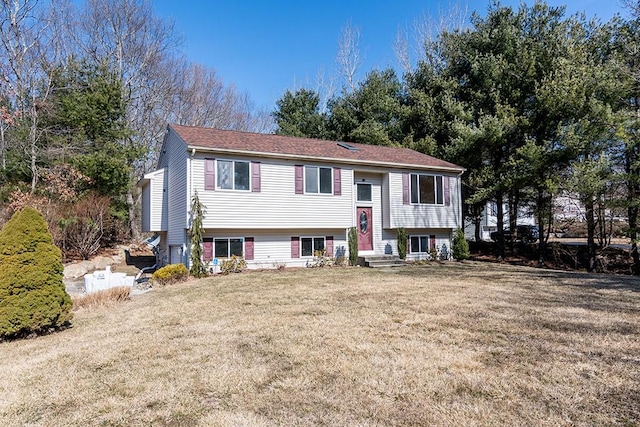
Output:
[0, 0, 272, 258]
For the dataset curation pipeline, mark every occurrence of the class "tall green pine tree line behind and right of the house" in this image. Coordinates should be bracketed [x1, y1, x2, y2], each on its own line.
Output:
[273, 0, 640, 274]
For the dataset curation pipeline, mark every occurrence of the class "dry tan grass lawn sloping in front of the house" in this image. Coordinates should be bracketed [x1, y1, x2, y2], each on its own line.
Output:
[0, 262, 640, 426]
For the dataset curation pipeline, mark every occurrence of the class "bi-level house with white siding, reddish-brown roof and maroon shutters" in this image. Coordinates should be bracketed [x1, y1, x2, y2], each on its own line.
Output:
[139, 124, 464, 268]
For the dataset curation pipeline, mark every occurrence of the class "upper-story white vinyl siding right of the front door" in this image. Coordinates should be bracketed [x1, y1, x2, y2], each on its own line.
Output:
[384, 171, 462, 229]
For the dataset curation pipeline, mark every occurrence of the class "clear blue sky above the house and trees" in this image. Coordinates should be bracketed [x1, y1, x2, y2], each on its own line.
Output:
[152, 0, 625, 111]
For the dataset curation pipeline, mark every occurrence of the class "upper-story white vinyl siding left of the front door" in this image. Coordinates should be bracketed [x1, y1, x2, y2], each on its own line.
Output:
[192, 156, 353, 234]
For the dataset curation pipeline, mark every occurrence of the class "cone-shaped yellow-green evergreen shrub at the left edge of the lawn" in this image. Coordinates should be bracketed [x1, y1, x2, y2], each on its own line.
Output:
[0, 207, 72, 341]
